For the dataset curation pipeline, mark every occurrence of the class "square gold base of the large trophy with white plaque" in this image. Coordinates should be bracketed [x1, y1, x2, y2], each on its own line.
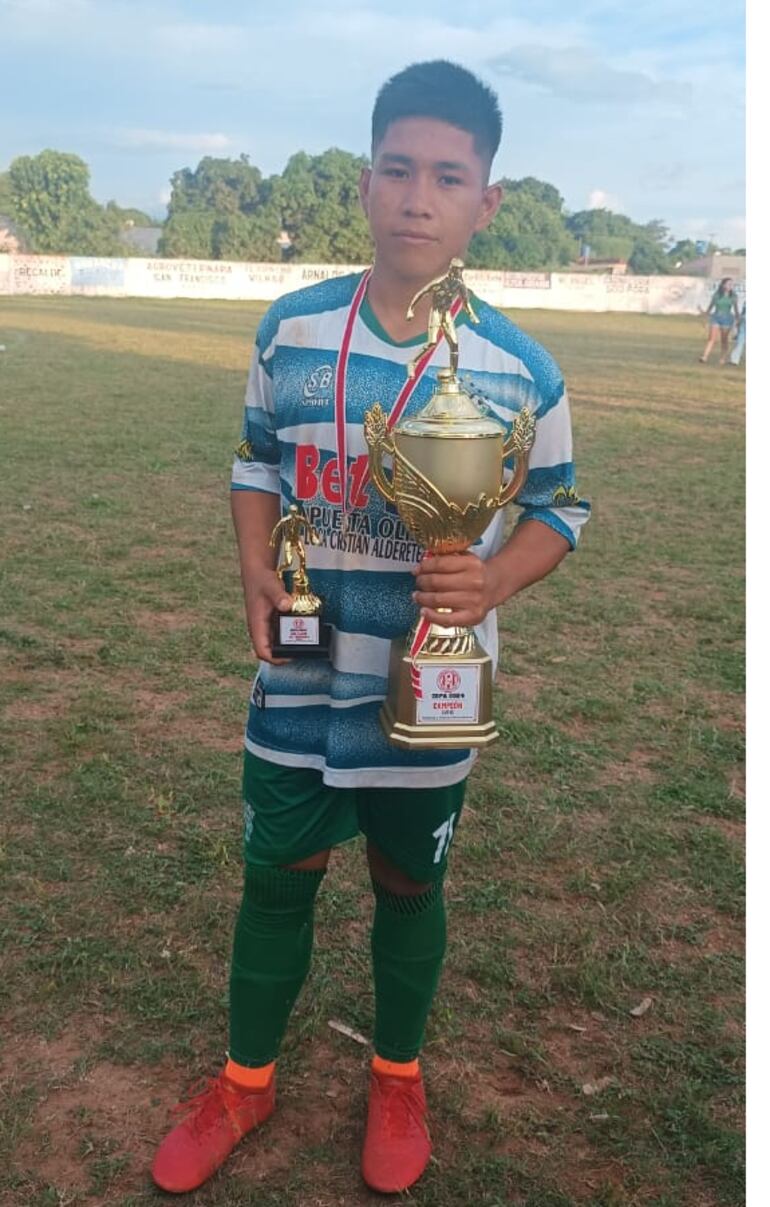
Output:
[380, 640, 500, 750]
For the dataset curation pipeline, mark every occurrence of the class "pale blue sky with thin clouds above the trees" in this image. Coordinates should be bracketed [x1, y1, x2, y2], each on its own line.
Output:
[0, 0, 746, 247]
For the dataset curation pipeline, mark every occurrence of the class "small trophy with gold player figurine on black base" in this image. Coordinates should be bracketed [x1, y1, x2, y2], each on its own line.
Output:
[269, 503, 331, 658]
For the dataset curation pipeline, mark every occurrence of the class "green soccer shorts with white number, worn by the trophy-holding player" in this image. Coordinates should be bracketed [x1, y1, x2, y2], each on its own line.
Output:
[244, 751, 466, 884]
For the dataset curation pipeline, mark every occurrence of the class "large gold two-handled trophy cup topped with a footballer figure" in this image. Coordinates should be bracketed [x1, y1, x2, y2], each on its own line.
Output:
[364, 260, 535, 750]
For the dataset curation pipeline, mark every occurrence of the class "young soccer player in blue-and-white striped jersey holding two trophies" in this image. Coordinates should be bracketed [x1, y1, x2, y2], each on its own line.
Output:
[152, 62, 588, 1193]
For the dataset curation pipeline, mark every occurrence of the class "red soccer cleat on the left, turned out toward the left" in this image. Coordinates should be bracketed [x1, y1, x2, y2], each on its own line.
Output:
[152, 1072, 275, 1194]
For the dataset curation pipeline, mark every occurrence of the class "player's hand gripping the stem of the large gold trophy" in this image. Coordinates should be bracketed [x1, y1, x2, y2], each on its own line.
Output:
[412, 553, 495, 625]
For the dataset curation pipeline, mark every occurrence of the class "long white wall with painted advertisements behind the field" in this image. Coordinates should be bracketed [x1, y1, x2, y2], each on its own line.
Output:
[0, 255, 716, 314]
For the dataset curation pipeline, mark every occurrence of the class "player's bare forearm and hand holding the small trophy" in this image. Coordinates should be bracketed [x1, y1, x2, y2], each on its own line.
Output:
[231, 490, 291, 665]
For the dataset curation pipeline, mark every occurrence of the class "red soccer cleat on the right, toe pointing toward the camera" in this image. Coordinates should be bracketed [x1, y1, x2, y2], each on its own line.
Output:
[361, 1069, 431, 1195]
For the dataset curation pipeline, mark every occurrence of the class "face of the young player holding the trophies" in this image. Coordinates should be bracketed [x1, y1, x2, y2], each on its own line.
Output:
[361, 117, 502, 284]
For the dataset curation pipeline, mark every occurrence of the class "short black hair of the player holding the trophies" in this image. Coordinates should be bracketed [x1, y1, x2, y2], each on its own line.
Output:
[372, 59, 502, 164]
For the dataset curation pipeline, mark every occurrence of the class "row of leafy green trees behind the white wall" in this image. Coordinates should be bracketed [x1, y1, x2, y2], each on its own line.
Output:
[0, 147, 743, 273]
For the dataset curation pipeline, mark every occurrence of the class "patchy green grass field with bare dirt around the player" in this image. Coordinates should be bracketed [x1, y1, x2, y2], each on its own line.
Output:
[0, 298, 743, 1207]
